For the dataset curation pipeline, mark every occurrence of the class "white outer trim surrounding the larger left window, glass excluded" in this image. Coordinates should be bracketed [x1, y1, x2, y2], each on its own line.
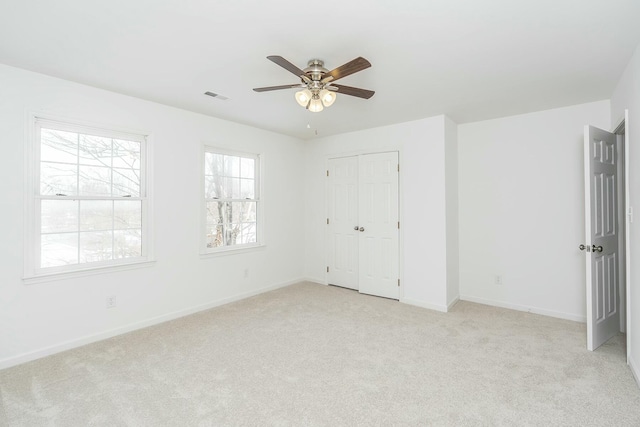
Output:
[23, 112, 155, 284]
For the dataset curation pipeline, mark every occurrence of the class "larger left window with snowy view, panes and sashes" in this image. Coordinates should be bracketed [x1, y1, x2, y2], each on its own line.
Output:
[27, 119, 148, 276]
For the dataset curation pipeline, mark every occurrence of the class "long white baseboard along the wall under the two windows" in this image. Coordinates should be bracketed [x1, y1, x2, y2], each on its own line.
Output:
[0, 278, 308, 369]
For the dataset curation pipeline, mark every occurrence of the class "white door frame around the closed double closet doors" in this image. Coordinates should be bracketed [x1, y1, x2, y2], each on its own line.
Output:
[323, 148, 404, 301]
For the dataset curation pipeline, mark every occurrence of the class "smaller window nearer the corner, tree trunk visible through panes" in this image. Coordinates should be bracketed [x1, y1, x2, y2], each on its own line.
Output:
[203, 147, 262, 252]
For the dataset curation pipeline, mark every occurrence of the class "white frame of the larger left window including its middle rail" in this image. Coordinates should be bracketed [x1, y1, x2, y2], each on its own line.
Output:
[23, 113, 154, 284]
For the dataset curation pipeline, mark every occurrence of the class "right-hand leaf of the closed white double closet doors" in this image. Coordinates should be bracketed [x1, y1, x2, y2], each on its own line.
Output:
[358, 152, 399, 299]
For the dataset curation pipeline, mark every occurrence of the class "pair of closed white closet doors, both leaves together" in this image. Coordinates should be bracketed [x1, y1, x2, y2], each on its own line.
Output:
[327, 152, 399, 299]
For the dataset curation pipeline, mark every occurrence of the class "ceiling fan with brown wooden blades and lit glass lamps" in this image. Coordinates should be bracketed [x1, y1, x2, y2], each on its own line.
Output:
[253, 55, 375, 113]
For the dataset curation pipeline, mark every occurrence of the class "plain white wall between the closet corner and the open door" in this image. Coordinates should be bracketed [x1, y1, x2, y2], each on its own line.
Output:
[458, 101, 611, 321]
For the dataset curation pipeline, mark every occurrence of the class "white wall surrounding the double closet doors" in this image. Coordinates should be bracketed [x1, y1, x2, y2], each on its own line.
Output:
[305, 116, 454, 311]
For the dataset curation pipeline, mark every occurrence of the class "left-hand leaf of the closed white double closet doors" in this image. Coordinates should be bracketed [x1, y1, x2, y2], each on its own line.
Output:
[327, 156, 359, 290]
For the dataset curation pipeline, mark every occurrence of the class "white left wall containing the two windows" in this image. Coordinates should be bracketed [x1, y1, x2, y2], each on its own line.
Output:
[0, 66, 304, 368]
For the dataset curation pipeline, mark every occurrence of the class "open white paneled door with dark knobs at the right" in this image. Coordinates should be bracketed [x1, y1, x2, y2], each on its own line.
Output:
[580, 126, 620, 351]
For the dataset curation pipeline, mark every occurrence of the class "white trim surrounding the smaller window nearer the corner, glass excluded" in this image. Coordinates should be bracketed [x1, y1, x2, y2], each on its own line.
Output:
[198, 143, 266, 258]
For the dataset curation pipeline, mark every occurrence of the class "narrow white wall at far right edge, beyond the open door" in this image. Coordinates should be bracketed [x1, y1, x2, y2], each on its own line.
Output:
[611, 42, 640, 383]
